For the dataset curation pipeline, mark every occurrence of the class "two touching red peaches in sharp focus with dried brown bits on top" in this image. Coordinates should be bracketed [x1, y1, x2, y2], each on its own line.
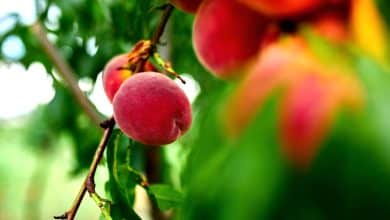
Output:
[103, 41, 192, 146]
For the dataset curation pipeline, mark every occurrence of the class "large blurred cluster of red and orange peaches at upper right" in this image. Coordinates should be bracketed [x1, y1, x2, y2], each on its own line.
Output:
[171, 0, 383, 167]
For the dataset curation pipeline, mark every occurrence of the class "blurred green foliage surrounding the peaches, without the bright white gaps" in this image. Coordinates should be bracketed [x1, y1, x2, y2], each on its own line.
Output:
[0, 0, 390, 220]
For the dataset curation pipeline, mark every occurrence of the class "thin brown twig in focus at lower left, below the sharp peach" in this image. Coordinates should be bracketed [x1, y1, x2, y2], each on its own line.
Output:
[54, 118, 115, 220]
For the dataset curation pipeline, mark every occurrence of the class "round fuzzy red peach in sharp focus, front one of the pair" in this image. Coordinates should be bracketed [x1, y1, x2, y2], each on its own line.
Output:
[113, 72, 192, 146]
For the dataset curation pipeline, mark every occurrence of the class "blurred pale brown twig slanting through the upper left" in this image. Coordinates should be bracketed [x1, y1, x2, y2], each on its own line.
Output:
[30, 21, 103, 125]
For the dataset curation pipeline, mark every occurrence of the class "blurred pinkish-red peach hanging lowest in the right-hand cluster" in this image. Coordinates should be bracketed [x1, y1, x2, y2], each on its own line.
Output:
[279, 74, 336, 168]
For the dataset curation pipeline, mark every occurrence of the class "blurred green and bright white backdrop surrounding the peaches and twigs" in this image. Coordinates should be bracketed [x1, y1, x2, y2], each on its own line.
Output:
[0, 0, 390, 220]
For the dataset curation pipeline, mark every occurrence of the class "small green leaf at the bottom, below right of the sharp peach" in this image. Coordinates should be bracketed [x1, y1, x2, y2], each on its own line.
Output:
[148, 184, 183, 211]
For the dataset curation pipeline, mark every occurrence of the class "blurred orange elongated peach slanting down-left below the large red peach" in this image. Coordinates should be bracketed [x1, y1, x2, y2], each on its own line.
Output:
[224, 38, 310, 136]
